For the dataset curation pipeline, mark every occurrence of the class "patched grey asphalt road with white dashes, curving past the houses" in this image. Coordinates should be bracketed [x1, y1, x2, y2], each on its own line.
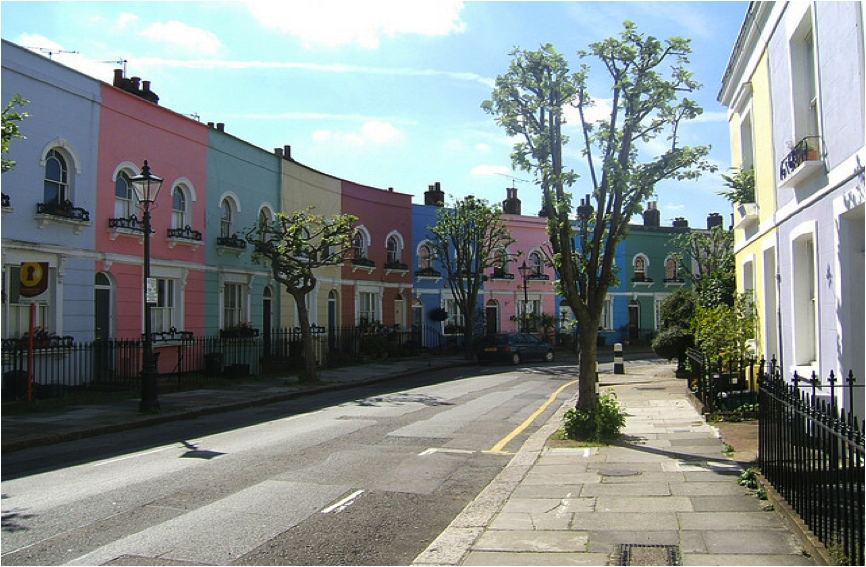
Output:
[2, 363, 576, 565]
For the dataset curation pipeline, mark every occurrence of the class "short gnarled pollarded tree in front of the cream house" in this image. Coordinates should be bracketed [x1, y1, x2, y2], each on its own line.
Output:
[246, 208, 358, 381]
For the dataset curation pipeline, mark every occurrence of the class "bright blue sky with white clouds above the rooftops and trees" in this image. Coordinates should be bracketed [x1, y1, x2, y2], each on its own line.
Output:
[0, 0, 748, 227]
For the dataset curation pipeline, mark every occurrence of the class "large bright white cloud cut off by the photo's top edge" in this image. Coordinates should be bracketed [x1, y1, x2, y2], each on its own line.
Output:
[247, 0, 466, 49]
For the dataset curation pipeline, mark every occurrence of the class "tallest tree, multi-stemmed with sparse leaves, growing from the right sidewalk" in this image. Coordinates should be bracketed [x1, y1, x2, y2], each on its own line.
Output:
[482, 21, 714, 411]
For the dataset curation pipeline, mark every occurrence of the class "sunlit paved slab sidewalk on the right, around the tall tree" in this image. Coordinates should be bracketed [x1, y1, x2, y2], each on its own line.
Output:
[414, 363, 823, 565]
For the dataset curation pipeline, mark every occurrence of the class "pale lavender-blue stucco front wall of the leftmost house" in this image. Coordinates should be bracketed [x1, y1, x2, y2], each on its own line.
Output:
[2, 41, 100, 341]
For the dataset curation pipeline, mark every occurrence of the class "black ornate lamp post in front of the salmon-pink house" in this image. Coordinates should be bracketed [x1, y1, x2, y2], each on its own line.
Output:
[129, 160, 162, 412]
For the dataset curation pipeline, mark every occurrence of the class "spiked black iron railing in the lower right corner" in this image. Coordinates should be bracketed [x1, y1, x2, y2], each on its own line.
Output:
[758, 360, 866, 565]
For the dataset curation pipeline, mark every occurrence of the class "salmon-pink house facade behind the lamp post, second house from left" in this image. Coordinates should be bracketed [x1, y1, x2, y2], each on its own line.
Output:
[96, 81, 208, 364]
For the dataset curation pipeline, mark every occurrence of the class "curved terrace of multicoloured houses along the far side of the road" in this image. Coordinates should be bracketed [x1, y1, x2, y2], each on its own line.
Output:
[2, 37, 708, 369]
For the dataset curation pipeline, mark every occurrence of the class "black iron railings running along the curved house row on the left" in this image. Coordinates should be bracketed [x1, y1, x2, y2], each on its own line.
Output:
[2, 326, 445, 402]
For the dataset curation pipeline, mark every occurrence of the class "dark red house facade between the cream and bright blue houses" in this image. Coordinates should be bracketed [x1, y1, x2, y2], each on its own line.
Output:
[341, 180, 414, 327]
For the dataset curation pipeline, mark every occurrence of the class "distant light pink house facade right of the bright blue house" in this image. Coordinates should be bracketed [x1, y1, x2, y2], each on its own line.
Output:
[483, 214, 556, 338]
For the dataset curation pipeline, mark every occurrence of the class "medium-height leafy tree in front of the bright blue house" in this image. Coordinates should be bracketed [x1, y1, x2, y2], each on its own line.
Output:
[428, 195, 514, 360]
